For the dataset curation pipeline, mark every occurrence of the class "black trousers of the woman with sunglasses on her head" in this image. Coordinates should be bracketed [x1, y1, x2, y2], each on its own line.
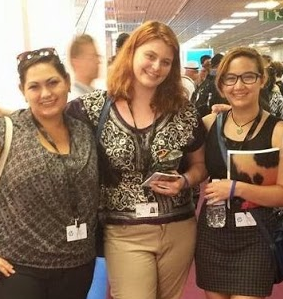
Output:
[0, 261, 95, 299]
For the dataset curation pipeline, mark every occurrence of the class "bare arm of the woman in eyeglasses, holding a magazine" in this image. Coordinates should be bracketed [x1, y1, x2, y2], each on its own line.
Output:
[205, 122, 283, 207]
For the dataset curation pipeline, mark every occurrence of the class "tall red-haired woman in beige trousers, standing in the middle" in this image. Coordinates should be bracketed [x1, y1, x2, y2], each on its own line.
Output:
[69, 21, 206, 299]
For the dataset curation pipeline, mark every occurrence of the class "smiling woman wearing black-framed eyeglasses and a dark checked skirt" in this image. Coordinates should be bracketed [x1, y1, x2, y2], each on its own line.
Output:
[196, 48, 283, 299]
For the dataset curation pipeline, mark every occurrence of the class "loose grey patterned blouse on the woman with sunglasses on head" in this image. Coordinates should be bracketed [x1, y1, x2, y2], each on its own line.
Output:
[0, 109, 99, 268]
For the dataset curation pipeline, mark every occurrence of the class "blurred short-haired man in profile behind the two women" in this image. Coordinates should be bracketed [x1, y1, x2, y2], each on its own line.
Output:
[69, 34, 101, 100]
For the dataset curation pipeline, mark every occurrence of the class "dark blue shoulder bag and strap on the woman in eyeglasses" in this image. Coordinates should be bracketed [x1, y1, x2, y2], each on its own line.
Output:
[216, 113, 283, 283]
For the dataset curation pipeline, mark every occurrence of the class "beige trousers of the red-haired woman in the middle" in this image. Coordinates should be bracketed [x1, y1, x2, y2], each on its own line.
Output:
[105, 218, 196, 299]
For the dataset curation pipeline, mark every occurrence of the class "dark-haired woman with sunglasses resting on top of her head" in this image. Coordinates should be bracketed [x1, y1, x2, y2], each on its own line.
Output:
[0, 48, 99, 299]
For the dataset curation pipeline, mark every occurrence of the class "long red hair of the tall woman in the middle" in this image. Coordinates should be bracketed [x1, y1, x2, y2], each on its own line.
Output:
[107, 21, 188, 113]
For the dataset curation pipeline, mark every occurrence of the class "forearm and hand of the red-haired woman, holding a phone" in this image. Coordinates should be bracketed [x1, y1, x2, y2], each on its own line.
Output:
[150, 145, 207, 196]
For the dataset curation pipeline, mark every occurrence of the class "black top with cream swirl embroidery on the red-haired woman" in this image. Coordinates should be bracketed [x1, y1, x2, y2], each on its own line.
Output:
[68, 90, 204, 224]
